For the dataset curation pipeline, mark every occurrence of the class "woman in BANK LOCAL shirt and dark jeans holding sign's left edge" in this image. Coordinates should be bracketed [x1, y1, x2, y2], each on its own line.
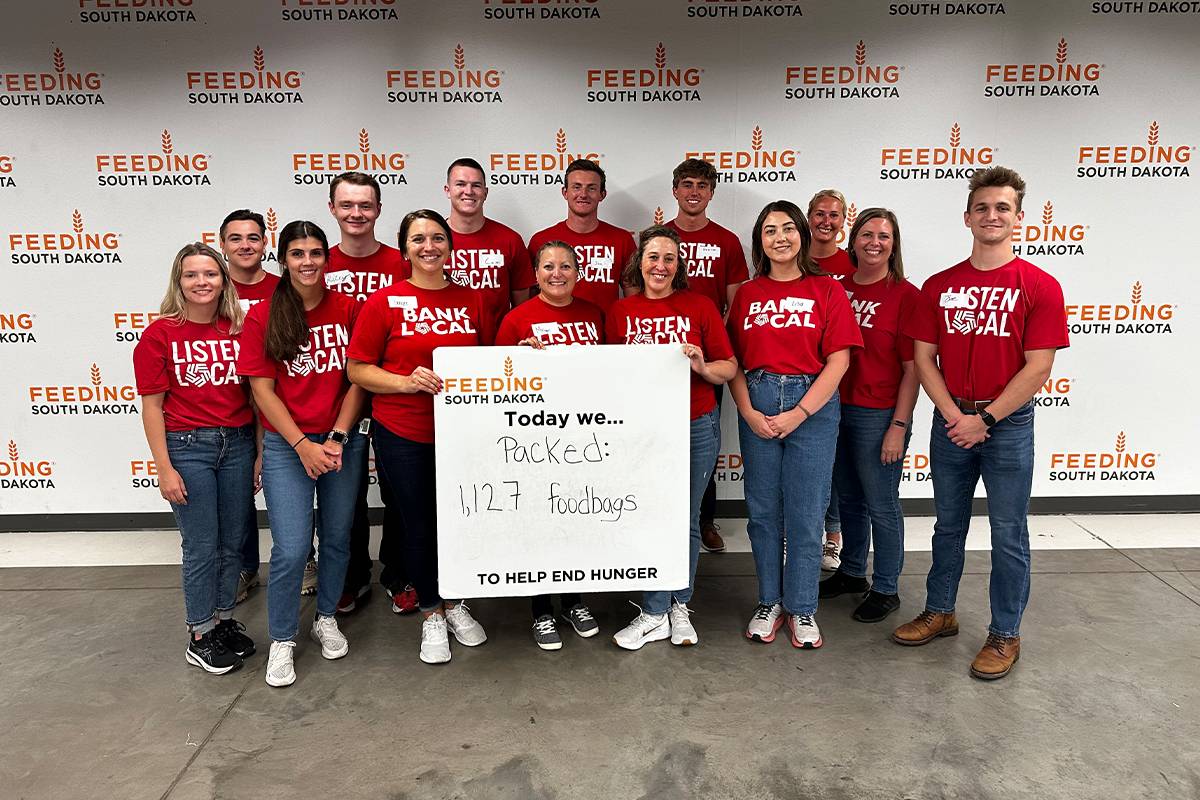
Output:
[348, 209, 496, 663]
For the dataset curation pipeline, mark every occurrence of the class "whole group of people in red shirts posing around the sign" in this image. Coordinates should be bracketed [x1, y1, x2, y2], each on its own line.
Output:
[133, 158, 1068, 686]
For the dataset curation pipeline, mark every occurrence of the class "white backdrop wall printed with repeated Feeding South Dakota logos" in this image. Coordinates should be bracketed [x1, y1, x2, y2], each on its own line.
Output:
[0, 0, 1200, 515]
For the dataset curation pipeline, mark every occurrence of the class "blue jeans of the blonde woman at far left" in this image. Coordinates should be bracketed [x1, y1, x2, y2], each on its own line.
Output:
[167, 425, 257, 633]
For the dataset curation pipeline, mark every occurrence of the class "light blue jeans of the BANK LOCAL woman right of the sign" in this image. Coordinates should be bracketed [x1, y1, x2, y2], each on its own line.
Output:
[738, 369, 841, 614]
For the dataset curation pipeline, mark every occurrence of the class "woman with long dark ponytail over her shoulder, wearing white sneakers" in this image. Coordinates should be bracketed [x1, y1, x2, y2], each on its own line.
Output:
[238, 221, 367, 686]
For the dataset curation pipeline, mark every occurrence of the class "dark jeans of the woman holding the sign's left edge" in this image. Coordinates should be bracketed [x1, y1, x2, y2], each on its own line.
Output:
[374, 420, 442, 612]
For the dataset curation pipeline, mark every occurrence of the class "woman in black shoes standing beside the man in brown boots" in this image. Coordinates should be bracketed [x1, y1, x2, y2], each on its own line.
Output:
[820, 209, 920, 622]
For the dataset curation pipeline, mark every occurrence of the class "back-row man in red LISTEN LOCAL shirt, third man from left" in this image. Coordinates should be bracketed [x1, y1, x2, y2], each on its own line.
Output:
[445, 158, 536, 324]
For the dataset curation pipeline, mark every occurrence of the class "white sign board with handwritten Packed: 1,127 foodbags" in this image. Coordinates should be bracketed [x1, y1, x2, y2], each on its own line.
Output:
[433, 345, 690, 597]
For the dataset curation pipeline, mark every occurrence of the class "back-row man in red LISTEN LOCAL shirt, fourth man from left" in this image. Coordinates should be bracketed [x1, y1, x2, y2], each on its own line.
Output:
[528, 158, 637, 312]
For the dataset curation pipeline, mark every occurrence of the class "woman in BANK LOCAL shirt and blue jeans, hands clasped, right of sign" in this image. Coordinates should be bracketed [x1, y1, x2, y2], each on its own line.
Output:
[728, 200, 863, 648]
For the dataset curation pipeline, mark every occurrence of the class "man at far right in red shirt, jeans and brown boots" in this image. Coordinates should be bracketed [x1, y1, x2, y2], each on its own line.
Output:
[892, 167, 1068, 679]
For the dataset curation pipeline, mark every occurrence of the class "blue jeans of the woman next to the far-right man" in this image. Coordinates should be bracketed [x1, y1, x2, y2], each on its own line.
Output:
[833, 405, 912, 595]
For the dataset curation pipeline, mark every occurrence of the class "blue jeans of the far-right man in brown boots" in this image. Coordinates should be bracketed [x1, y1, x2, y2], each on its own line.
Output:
[925, 401, 1033, 638]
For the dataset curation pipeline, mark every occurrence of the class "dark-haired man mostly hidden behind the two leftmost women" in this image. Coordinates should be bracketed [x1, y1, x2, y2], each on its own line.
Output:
[221, 209, 278, 603]
